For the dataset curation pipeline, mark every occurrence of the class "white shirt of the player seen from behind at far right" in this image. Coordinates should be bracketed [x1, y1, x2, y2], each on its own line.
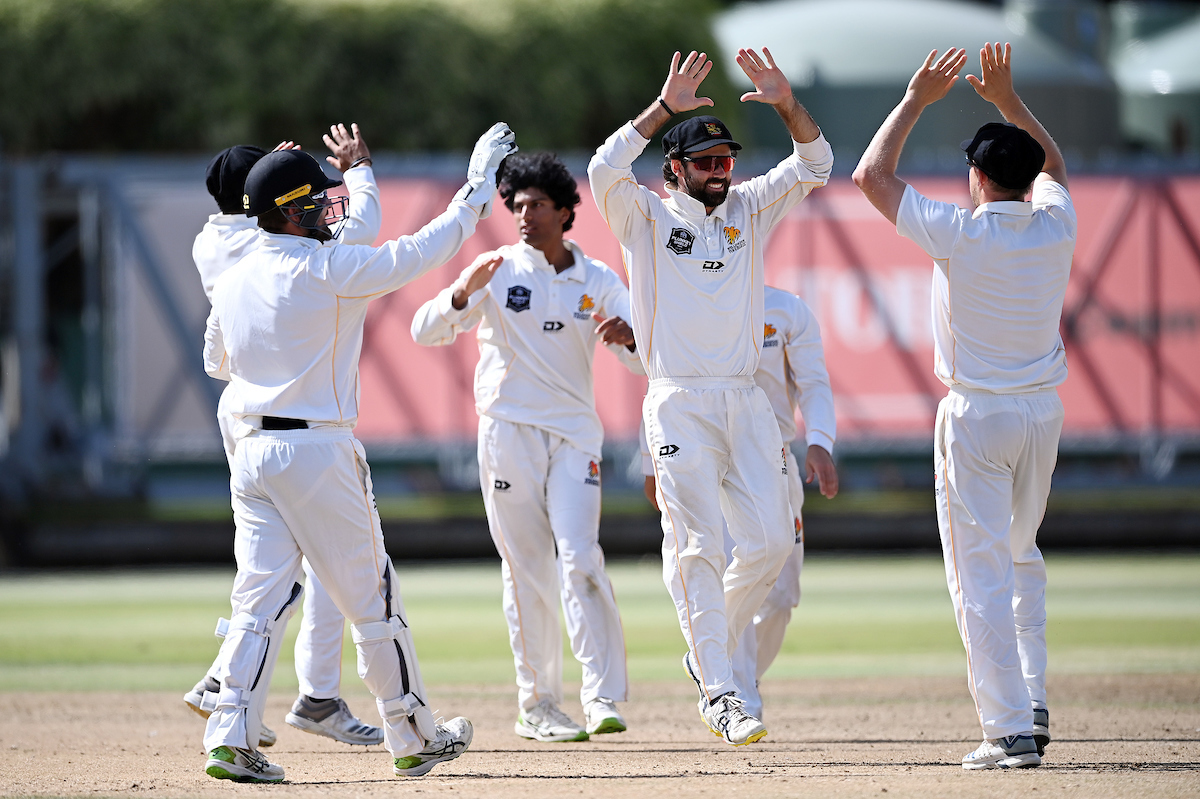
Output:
[896, 180, 1076, 394]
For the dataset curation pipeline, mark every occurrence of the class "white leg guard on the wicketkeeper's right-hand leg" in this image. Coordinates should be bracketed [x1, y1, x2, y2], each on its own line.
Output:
[350, 564, 437, 749]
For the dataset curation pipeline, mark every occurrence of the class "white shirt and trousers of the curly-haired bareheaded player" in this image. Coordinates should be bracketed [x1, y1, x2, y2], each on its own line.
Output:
[412, 241, 642, 710]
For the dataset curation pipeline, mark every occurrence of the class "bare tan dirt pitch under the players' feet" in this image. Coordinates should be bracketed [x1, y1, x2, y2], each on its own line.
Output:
[0, 674, 1200, 799]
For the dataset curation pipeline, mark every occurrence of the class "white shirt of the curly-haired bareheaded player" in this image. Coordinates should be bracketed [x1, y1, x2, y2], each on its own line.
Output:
[412, 241, 642, 456]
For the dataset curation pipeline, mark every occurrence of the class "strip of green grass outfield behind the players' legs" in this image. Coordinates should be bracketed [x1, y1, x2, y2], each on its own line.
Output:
[0, 553, 1200, 691]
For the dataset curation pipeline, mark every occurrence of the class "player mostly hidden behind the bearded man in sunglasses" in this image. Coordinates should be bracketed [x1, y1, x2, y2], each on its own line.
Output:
[642, 286, 838, 719]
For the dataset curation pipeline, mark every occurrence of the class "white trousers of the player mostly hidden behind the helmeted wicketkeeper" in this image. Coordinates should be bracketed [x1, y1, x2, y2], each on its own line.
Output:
[209, 384, 346, 699]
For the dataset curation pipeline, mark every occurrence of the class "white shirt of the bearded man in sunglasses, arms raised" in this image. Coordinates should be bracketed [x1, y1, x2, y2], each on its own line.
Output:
[588, 122, 833, 379]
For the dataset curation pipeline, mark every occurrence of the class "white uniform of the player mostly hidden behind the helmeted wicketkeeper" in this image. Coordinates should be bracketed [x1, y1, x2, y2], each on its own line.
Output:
[192, 164, 383, 699]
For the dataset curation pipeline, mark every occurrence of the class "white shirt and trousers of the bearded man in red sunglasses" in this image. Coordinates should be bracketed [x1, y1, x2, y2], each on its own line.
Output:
[588, 122, 833, 701]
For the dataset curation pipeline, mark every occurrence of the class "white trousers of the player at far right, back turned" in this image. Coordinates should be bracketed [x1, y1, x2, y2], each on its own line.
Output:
[934, 388, 1063, 738]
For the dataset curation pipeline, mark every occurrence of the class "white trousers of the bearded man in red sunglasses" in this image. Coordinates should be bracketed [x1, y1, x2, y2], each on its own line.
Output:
[642, 377, 796, 701]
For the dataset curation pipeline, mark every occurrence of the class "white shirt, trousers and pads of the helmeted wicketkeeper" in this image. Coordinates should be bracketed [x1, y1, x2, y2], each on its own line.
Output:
[204, 195, 478, 757]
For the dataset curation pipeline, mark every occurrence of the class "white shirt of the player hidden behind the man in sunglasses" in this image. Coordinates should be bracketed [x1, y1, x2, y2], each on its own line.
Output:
[754, 286, 838, 455]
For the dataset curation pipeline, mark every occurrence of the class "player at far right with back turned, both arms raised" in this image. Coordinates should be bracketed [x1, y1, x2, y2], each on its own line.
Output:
[854, 43, 1076, 769]
